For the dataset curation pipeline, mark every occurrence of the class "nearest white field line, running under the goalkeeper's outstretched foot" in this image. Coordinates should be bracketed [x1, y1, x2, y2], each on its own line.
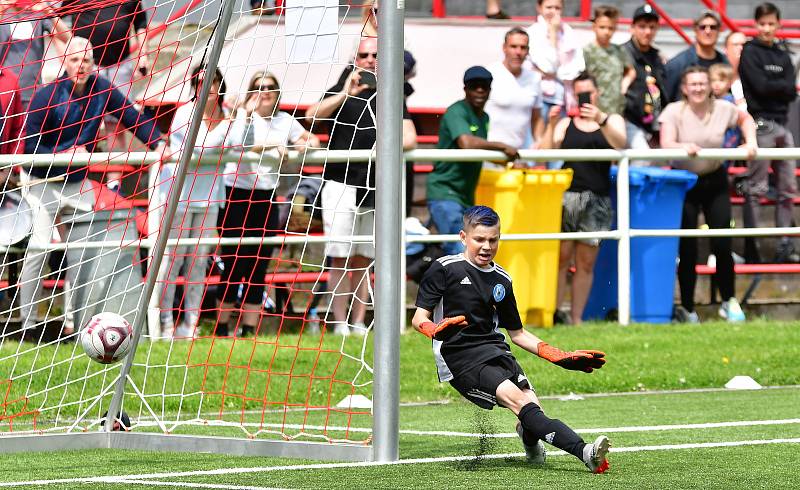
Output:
[0, 437, 800, 490]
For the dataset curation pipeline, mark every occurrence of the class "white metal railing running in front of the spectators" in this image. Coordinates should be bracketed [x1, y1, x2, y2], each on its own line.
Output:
[0, 148, 800, 325]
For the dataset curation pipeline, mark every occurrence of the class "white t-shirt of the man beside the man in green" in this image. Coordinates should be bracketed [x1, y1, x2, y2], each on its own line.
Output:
[484, 62, 542, 148]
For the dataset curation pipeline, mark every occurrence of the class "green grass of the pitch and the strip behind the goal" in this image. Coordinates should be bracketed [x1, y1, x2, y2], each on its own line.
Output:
[0, 321, 800, 489]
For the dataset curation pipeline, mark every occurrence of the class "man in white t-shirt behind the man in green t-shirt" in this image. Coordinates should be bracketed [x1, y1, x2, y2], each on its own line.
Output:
[484, 27, 544, 153]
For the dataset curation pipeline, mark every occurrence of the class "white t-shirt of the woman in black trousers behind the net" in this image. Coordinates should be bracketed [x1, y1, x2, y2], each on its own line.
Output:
[225, 111, 305, 190]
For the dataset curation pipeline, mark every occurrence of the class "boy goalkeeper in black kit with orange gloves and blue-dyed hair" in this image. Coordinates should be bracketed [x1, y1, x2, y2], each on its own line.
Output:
[412, 206, 609, 473]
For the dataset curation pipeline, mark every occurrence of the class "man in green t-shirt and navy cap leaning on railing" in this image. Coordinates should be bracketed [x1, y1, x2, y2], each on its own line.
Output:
[427, 66, 519, 255]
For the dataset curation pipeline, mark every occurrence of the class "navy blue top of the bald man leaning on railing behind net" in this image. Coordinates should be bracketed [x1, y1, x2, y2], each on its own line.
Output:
[25, 75, 161, 182]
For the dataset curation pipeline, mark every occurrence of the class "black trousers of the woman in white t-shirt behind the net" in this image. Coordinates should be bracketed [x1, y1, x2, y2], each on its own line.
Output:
[217, 187, 278, 304]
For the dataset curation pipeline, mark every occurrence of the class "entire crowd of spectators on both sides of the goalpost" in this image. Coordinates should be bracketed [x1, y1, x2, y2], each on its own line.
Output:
[0, 0, 799, 337]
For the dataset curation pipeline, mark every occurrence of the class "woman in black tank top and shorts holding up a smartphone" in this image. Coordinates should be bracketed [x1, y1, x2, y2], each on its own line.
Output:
[540, 72, 627, 324]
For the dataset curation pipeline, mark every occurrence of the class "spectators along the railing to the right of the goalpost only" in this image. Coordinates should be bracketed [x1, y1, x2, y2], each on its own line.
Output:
[427, 0, 800, 330]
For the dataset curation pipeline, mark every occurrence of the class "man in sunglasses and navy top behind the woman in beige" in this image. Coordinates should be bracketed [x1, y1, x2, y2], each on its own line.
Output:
[665, 10, 729, 102]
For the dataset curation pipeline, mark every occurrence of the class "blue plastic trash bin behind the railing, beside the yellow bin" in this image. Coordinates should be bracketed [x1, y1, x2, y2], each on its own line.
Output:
[583, 167, 697, 323]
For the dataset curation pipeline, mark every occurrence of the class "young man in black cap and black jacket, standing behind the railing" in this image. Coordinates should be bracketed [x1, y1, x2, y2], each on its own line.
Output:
[623, 5, 665, 155]
